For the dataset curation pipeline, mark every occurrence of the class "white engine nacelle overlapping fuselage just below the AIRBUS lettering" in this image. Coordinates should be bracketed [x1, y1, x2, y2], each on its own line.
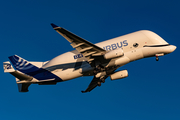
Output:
[104, 49, 124, 59]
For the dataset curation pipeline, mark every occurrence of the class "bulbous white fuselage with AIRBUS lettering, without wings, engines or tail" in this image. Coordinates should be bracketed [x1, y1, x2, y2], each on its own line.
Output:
[43, 30, 176, 81]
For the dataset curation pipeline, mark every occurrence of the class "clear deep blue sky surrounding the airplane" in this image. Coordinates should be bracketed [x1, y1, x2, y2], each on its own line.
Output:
[0, 0, 180, 120]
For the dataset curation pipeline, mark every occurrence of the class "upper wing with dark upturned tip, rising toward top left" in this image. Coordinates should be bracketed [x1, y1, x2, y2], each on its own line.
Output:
[51, 23, 106, 63]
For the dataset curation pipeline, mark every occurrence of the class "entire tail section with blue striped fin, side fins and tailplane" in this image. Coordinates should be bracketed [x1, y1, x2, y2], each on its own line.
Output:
[3, 55, 62, 92]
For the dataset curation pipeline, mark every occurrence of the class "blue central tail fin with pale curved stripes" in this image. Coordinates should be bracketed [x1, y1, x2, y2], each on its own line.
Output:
[9, 55, 40, 76]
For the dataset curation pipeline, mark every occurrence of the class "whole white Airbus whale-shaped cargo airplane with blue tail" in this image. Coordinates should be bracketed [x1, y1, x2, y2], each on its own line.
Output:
[3, 23, 176, 93]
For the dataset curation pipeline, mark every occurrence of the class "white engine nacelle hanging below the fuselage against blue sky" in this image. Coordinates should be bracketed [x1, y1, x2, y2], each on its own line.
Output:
[110, 70, 128, 80]
